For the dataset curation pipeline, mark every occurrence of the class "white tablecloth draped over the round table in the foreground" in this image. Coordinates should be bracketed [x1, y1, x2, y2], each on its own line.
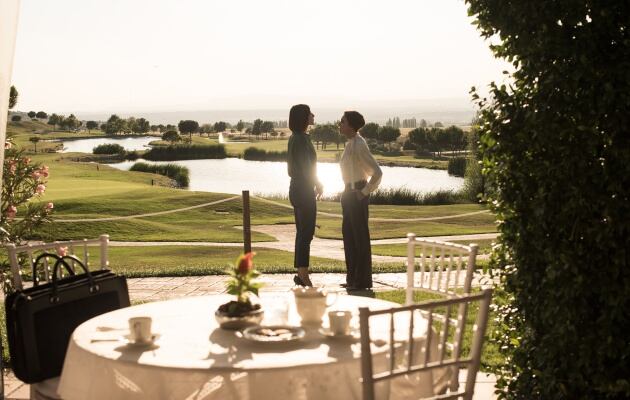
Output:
[58, 293, 443, 400]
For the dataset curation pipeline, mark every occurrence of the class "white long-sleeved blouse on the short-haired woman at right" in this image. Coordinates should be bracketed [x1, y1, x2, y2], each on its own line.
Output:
[339, 133, 383, 196]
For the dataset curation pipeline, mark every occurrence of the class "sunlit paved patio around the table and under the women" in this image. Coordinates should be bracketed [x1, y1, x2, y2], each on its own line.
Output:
[4, 273, 496, 400]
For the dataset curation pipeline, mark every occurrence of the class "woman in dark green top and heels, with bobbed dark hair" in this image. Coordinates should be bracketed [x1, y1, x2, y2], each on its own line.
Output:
[287, 104, 323, 286]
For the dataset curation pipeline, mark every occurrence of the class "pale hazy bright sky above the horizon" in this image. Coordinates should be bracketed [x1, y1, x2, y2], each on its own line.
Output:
[13, 0, 506, 112]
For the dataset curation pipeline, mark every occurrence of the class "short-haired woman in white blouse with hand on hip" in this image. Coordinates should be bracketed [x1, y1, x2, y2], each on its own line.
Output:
[339, 111, 383, 290]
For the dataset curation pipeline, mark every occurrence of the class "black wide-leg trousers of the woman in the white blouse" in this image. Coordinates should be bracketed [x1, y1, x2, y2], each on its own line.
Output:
[341, 190, 372, 288]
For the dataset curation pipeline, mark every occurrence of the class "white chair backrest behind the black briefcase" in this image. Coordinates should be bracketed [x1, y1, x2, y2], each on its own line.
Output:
[5, 231, 109, 290]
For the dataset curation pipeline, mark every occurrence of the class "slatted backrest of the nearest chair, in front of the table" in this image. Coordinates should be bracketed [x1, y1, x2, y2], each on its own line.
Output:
[359, 289, 492, 400]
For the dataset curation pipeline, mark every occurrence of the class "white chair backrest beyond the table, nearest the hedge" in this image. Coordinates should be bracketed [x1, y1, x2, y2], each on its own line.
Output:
[405, 233, 478, 304]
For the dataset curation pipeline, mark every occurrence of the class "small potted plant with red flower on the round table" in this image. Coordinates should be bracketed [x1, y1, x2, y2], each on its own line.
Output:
[214, 252, 263, 329]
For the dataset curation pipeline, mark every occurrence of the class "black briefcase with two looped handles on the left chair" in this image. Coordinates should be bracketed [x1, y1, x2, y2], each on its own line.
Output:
[5, 253, 129, 383]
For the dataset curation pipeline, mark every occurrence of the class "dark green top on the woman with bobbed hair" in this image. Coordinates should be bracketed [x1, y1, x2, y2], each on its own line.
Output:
[287, 132, 317, 185]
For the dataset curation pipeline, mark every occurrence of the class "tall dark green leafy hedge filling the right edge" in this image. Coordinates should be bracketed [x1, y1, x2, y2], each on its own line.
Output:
[466, 0, 630, 399]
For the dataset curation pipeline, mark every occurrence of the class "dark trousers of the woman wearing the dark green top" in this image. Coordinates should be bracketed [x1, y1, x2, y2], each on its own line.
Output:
[289, 179, 317, 268]
